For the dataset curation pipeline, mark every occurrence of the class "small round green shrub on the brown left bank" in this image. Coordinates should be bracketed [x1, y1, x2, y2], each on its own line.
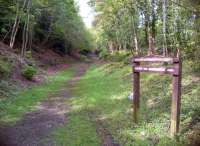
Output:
[22, 66, 37, 80]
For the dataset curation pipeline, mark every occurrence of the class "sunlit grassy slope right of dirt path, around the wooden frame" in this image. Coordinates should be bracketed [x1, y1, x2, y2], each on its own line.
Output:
[54, 64, 200, 146]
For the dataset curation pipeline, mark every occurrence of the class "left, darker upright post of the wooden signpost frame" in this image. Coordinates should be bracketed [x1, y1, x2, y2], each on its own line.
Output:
[133, 62, 140, 123]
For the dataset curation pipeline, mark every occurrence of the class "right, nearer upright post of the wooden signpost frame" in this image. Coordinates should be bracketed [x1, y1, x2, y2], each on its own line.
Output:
[170, 61, 182, 137]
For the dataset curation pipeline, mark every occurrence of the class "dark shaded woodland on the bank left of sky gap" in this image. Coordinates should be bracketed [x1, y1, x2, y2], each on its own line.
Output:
[0, 0, 92, 56]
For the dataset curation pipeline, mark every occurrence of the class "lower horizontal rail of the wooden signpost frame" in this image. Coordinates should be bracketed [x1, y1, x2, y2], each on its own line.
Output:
[134, 66, 175, 74]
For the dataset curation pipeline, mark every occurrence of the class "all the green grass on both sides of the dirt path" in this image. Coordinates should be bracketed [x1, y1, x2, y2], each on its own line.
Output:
[0, 60, 200, 146]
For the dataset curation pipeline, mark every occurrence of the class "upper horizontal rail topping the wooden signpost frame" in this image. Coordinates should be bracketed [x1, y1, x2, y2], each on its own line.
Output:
[133, 56, 179, 63]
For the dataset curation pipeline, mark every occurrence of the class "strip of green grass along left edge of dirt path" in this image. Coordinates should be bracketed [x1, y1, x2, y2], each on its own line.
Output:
[0, 69, 74, 123]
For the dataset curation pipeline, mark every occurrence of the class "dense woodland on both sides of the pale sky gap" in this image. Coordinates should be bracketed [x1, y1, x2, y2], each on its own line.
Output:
[0, 0, 200, 70]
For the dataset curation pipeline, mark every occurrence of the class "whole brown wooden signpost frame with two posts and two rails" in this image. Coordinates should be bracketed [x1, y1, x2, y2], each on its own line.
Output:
[133, 56, 182, 137]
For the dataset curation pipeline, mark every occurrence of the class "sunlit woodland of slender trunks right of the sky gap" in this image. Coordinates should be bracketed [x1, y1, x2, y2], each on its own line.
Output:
[90, 0, 200, 70]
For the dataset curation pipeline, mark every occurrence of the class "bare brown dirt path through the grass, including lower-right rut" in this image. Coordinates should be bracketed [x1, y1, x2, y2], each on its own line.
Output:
[0, 63, 117, 146]
